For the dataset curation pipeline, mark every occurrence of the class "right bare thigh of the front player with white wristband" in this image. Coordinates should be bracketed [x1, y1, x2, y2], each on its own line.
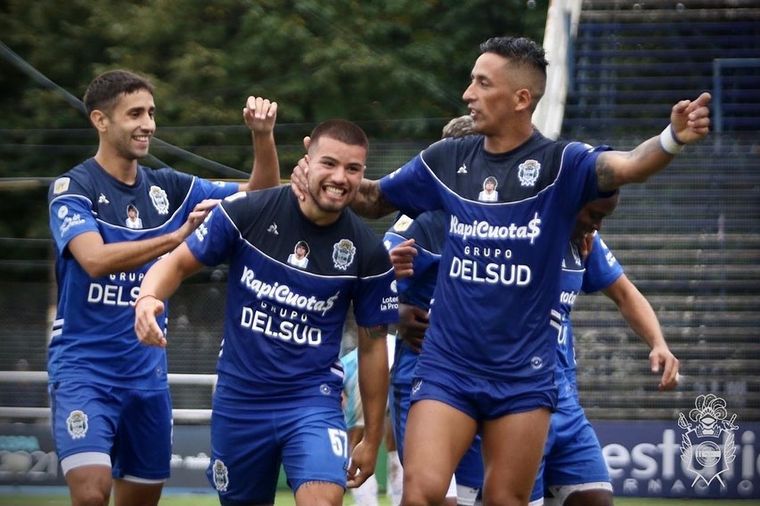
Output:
[482, 408, 550, 504]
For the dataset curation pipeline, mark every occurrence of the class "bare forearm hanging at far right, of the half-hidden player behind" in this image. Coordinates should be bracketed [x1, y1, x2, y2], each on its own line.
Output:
[604, 274, 679, 390]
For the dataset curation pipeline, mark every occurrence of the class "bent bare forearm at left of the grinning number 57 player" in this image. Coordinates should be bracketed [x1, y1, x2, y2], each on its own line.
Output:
[135, 243, 203, 347]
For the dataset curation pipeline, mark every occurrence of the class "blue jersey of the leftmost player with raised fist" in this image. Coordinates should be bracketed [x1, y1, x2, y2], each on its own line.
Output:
[48, 158, 238, 389]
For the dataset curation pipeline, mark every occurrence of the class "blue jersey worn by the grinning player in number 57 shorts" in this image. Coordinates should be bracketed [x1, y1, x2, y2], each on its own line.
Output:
[187, 187, 398, 406]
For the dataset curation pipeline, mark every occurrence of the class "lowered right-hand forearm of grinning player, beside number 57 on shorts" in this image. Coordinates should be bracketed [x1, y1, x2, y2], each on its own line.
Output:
[347, 325, 388, 488]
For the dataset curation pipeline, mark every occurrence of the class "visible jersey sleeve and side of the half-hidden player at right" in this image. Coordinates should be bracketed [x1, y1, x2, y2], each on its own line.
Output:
[557, 233, 623, 389]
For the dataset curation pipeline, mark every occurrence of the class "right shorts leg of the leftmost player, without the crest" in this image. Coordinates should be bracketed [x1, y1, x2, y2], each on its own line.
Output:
[113, 389, 172, 480]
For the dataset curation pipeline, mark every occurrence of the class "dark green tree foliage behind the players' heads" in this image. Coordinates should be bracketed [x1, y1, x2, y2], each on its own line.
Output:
[0, 0, 548, 241]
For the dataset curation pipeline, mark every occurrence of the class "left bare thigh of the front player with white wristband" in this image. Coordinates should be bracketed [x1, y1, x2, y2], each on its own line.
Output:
[404, 399, 477, 497]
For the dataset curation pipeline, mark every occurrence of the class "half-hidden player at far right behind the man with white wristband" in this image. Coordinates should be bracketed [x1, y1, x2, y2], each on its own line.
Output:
[531, 193, 679, 506]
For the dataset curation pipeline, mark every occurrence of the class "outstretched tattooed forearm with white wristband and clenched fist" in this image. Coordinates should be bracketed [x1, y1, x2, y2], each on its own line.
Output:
[596, 93, 711, 191]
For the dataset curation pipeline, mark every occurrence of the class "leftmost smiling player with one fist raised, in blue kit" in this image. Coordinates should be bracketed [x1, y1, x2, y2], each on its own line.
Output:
[48, 70, 279, 506]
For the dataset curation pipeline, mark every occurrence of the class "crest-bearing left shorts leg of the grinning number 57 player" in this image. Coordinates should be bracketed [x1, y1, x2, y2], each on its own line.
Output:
[206, 408, 281, 505]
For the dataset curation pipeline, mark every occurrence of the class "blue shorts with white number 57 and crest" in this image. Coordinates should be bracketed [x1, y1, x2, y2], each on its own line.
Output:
[206, 390, 349, 505]
